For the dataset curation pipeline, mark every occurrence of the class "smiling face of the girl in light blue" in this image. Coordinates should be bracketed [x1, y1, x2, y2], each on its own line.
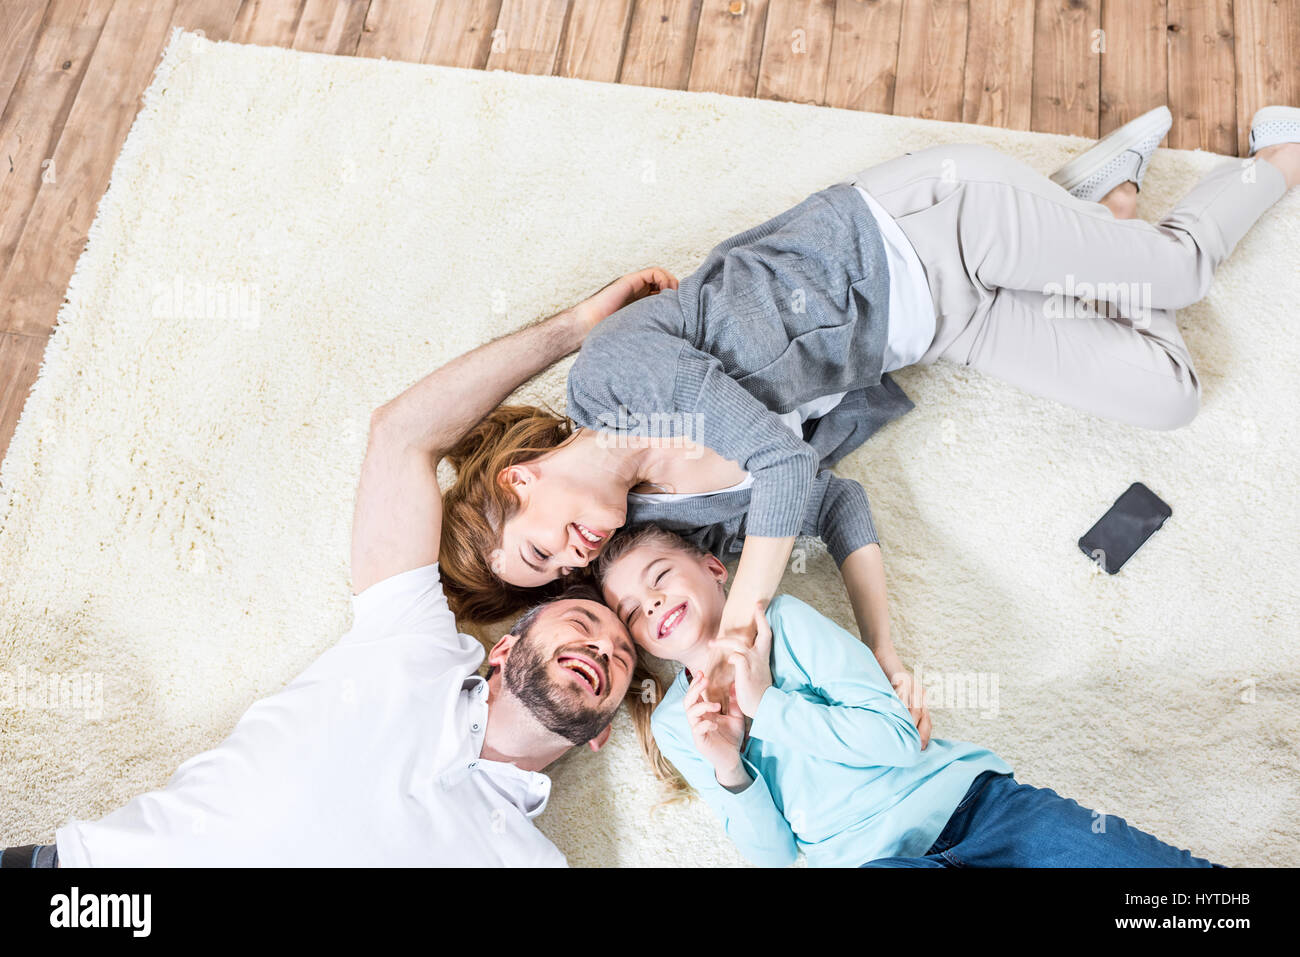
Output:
[601, 542, 727, 662]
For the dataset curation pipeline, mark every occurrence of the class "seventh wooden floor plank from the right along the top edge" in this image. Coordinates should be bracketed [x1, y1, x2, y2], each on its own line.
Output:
[826, 0, 902, 113]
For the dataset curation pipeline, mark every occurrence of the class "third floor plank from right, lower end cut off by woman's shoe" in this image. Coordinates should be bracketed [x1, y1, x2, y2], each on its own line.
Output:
[1099, 0, 1169, 137]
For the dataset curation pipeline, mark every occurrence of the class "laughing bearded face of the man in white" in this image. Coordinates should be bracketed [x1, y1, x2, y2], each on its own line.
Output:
[502, 599, 637, 744]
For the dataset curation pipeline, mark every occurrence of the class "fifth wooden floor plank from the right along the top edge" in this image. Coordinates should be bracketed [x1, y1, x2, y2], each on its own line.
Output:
[962, 0, 1034, 130]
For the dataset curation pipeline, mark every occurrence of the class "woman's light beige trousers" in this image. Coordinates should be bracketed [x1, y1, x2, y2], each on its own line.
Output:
[848, 144, 1286, 429]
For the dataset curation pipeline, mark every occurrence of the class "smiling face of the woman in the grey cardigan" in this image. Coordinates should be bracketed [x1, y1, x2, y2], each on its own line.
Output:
[491, 460, 628, 588]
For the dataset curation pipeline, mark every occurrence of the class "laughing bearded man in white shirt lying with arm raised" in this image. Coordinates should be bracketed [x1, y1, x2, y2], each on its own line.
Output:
[0, 270, 650, 867]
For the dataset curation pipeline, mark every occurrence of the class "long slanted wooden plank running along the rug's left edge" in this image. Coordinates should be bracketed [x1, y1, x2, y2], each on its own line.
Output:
[0, 0, 176, 334]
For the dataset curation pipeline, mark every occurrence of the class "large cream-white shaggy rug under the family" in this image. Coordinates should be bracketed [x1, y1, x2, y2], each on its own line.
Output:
[0, 35, 1300, 866]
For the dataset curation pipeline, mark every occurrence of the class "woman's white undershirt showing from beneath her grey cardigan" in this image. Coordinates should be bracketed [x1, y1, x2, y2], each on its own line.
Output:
[628, 186, 935, 505]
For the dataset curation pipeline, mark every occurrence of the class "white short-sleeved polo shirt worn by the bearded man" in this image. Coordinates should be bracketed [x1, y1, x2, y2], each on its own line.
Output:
[56, 564, 566, 867]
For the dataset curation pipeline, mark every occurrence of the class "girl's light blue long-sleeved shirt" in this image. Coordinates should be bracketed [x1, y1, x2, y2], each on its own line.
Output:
[651, 596, 1011, 867]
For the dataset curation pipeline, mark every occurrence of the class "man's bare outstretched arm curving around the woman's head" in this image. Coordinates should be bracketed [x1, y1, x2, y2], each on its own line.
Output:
[352, 269, 677, 594]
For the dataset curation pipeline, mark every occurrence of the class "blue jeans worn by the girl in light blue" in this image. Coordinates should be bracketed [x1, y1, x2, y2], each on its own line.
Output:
[862, 771, 1217, 867]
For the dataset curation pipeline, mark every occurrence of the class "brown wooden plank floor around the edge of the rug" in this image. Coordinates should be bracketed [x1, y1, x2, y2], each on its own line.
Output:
[0, 0, 1300, 455]
